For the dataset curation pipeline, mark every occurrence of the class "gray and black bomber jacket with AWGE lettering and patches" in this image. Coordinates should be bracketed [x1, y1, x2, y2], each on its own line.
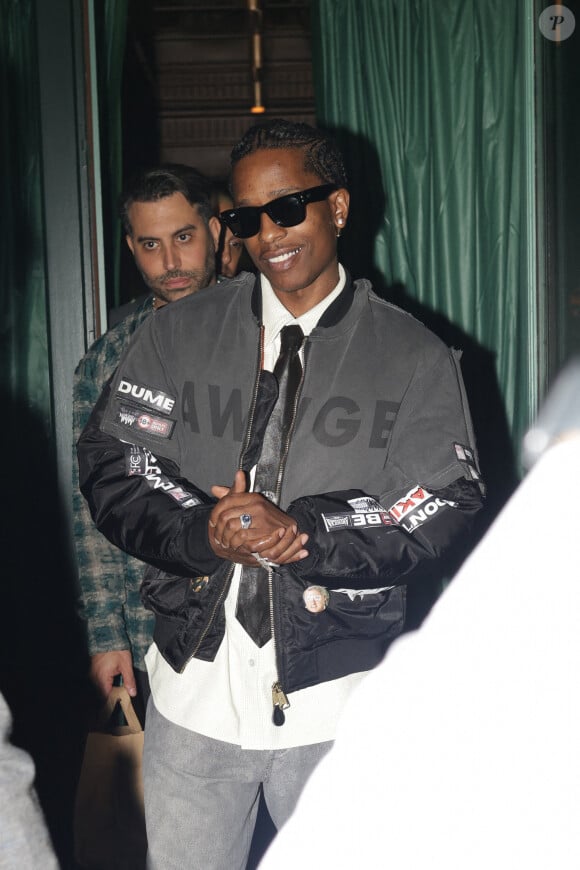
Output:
[78, 273, 483, 704]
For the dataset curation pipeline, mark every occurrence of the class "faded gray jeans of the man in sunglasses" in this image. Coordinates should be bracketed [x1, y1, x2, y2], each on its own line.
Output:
[143, 699, 332, 870]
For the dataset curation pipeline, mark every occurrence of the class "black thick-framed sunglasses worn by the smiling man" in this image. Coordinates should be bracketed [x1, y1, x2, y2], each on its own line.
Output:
[219, 184, 338, 239]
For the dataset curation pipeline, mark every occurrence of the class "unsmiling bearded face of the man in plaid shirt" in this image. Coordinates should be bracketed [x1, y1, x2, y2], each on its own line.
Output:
[126, 193, 220, 304]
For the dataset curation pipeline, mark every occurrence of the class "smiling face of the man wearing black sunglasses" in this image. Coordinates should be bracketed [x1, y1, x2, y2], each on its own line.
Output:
[232, 148, 349, 317]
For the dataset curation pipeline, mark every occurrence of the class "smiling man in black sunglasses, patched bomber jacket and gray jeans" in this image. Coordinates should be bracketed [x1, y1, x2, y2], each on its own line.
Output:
[79, 120, 482, 870]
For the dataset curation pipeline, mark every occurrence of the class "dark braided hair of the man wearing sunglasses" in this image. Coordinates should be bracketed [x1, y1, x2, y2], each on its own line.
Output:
[230, 118, 348, 187]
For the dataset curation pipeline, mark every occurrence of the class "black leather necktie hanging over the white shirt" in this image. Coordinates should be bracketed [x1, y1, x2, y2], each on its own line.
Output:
[236, 326, 304, 647]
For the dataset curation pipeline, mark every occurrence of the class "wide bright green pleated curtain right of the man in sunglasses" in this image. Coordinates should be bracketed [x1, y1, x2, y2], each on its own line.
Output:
[312, 0, 535, 504]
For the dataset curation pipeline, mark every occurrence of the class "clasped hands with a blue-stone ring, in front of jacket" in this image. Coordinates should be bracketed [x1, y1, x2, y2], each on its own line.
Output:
[208, 471, 308, 567]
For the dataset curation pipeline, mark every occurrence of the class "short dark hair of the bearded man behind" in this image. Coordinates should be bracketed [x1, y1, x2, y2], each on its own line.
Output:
[119, 163, 213, 235]
